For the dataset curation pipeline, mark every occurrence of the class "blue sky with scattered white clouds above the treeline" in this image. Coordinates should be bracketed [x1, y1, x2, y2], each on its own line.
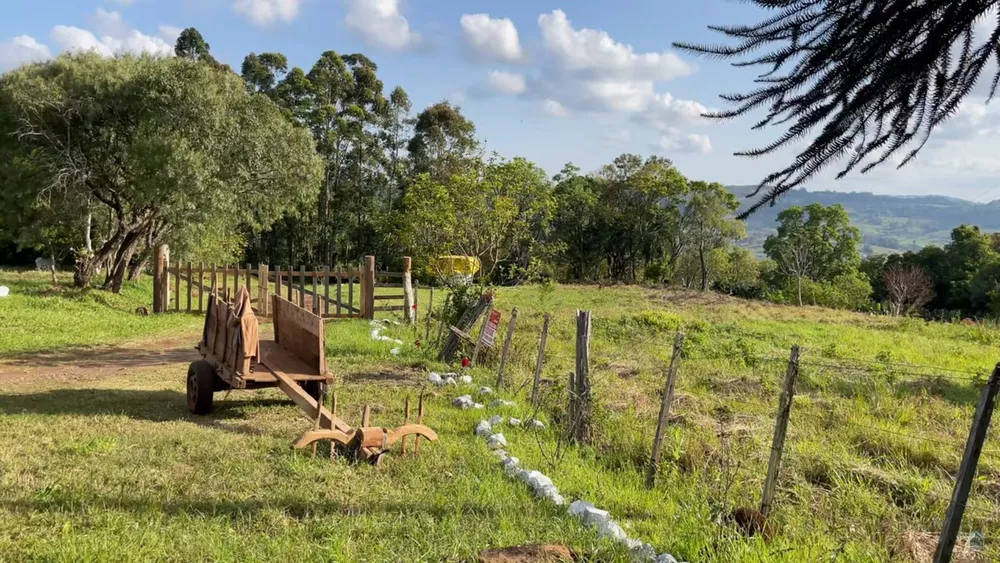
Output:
[0, 0, 1000, 201]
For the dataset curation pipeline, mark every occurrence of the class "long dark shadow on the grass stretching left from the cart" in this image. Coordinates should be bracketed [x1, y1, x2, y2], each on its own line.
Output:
[0, 389, 293, 434]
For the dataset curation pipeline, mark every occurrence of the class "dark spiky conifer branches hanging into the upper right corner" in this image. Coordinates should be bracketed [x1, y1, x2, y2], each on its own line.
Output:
[676, 0, 1000, 215]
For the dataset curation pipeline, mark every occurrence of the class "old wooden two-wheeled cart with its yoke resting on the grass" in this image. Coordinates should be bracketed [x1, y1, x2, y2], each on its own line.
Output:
[187, 287, 438, 464]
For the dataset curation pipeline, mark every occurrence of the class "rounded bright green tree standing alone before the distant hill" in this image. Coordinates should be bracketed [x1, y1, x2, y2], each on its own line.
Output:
[764, 203, 861, 305]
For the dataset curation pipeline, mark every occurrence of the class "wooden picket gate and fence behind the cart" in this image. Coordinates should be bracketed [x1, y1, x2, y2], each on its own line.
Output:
[153, 246, 416, 320]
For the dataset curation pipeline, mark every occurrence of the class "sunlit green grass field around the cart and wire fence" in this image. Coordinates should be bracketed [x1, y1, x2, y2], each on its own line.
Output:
[0, 274, 1000, 561]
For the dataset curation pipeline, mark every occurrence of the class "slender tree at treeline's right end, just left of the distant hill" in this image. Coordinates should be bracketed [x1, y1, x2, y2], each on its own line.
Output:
[686, 182, 746, 291]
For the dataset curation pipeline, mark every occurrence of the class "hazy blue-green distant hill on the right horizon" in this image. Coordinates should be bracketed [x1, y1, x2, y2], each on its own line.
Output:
[728, 186, 1000, 255]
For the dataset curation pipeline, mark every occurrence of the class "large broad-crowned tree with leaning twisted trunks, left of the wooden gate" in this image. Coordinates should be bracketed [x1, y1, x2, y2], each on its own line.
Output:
[0, 54, 319, 291]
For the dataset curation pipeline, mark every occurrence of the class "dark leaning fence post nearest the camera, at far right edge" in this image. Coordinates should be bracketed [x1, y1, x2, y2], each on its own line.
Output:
[934, 364, 1000, 563]
